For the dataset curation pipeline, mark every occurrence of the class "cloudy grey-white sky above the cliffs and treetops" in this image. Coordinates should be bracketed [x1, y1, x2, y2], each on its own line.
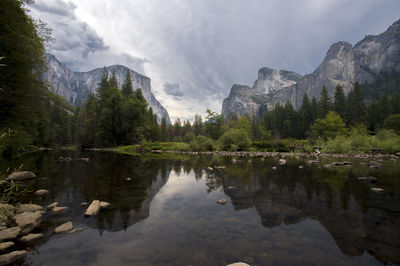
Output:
[29, 0, 400, 121]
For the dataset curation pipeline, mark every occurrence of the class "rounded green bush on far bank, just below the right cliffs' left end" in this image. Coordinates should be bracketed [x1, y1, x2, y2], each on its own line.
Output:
[219, 128, 251, 151]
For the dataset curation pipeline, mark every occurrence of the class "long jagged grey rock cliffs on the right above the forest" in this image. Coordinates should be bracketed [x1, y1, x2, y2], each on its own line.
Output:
[222, 20, 400, 117]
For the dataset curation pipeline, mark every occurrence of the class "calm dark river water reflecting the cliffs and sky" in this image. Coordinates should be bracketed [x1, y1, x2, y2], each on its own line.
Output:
[3, 152, 400, 265]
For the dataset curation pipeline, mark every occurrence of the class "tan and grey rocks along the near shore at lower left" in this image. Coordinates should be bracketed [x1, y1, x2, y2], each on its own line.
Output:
[0, 171, 110, 265]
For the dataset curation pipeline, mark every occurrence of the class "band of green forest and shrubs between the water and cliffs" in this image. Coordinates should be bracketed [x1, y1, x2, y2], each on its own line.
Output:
[0, 0, 400, 156]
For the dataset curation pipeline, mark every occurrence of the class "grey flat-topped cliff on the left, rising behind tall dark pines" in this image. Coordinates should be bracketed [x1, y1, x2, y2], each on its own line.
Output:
[43, 54, 170, 123]
